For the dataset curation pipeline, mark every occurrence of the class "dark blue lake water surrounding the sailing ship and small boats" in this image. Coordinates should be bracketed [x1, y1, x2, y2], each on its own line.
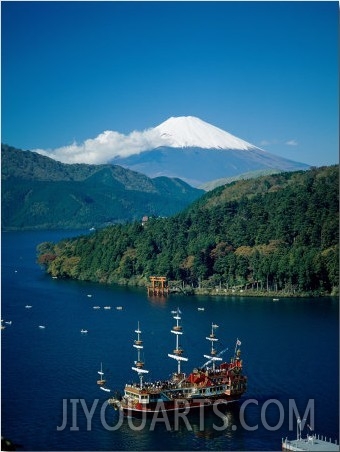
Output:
[1, 231, 339, 451]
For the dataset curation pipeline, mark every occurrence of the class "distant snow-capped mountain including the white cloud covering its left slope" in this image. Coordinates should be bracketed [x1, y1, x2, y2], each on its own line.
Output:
[34, 116, 308, 187]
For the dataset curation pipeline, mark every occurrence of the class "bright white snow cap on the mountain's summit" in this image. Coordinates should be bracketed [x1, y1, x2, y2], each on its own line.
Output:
[153, 116, 255, 150]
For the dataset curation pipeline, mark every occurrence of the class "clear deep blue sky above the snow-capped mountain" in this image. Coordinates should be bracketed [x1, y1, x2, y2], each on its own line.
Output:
[1, 1, 339, 166]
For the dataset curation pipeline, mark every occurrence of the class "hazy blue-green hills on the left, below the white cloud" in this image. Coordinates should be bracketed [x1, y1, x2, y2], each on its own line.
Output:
[1, 145, 203, 230]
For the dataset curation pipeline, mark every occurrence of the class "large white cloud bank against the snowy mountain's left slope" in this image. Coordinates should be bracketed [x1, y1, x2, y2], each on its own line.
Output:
[34, 129, 165, 164]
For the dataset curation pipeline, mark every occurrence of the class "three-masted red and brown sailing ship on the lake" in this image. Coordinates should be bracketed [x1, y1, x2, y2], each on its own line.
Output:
[108, 308, 247, 417]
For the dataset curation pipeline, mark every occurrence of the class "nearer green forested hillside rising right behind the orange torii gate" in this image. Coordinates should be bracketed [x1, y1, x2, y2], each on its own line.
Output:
[38, 166, 339, 295]
